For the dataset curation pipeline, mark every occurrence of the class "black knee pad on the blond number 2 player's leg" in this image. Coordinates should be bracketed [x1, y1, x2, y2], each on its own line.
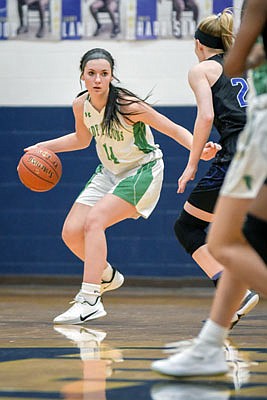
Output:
[174, 210, 208, 255]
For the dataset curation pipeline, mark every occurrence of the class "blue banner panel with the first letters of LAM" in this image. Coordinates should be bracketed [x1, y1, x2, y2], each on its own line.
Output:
[61, 0, 82, 40]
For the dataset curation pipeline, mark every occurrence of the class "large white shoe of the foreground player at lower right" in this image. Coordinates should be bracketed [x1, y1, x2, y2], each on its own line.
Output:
[151, 343, 229, 376]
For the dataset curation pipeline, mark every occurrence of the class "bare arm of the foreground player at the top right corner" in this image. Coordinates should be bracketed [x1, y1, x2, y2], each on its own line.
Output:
[224, 0, 267, 76]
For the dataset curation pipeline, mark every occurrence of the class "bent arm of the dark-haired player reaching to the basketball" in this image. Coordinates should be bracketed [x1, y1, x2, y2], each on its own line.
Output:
[24, 97, 92, 153]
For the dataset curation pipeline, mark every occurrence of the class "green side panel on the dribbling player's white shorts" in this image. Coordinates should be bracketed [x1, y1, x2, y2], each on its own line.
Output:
[113, 160, 157, 206]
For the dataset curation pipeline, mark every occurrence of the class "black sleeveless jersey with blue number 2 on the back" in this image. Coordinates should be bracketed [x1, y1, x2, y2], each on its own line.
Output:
[208, 54, 248, 162]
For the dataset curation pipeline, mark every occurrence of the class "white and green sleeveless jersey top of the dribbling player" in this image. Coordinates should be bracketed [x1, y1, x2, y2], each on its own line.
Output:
[84, 99, 162, 175]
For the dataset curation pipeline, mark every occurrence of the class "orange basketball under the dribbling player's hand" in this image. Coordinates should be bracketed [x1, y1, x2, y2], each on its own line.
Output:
[18, 147, 62, 192]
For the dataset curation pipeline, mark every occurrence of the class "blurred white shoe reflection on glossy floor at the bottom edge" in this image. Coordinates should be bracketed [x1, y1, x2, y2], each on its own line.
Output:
[150, 382, 231, 400]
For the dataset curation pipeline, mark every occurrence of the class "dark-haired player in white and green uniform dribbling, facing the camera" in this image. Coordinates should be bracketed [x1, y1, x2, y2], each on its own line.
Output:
[25, 48, 218, 324]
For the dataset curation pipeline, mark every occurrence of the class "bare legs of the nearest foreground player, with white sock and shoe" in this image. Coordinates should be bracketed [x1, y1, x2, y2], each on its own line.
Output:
[152, 196, 267, 376]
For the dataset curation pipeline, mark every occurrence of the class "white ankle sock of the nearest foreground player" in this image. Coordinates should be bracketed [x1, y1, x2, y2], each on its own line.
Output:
[198, 319, 229, 347]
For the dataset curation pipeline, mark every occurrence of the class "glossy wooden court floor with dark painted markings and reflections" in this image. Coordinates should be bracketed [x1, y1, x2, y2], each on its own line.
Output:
[0, 285, 267, 400]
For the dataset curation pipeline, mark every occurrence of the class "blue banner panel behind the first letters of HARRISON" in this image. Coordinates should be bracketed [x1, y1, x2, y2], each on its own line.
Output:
[136, 0, 157, 40]
